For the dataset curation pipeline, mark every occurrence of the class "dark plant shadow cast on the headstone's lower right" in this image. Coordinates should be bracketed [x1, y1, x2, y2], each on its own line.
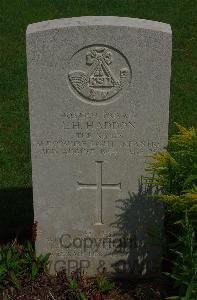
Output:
[110, 178, 164, 278]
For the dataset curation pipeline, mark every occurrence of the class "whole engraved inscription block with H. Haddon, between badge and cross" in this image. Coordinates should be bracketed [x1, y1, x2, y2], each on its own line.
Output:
[33, 110, 161, 160]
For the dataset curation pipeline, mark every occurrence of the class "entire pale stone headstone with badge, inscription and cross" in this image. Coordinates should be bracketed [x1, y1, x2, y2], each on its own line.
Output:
[27, 17, 171, 277]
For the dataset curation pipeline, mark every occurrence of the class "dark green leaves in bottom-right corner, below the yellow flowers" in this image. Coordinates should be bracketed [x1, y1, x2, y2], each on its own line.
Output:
[165, 213, 197, 300]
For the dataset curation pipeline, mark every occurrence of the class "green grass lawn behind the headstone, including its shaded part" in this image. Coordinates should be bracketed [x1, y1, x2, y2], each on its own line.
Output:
[0, 0, 197, 239]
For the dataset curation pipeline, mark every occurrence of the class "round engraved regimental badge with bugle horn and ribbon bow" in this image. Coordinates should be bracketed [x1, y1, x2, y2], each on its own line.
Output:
[68, 46, 131, 102]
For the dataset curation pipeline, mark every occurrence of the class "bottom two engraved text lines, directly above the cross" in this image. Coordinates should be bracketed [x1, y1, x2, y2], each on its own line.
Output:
[33, 137, 161, 158]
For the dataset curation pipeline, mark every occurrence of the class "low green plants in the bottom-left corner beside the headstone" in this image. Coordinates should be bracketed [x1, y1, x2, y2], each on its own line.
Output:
[0, 240, 50, 290]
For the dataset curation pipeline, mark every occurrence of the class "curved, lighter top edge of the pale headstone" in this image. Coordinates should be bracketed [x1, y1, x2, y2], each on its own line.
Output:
[27, 16, 171, 34]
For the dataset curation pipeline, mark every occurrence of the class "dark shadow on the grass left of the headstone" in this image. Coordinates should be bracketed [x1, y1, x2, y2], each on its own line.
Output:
[0, 188, 33, 243]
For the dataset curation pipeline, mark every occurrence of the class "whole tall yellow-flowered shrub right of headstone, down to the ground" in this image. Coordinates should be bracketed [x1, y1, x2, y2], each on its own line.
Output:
[146, 124, 197, 300]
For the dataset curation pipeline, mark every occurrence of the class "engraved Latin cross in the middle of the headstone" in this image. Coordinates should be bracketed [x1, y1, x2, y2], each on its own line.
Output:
[77, 161, 121, 225]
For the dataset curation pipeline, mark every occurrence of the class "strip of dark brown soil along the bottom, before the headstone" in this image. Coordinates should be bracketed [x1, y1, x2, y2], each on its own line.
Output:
[0, 272, 167, 300]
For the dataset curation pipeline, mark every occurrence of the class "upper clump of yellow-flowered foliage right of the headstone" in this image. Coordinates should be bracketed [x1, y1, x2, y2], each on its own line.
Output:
[147, 124, 197, 195]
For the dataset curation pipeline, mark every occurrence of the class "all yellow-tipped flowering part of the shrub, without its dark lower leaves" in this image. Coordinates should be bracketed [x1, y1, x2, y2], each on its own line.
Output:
[146, 124, 197, 222]
